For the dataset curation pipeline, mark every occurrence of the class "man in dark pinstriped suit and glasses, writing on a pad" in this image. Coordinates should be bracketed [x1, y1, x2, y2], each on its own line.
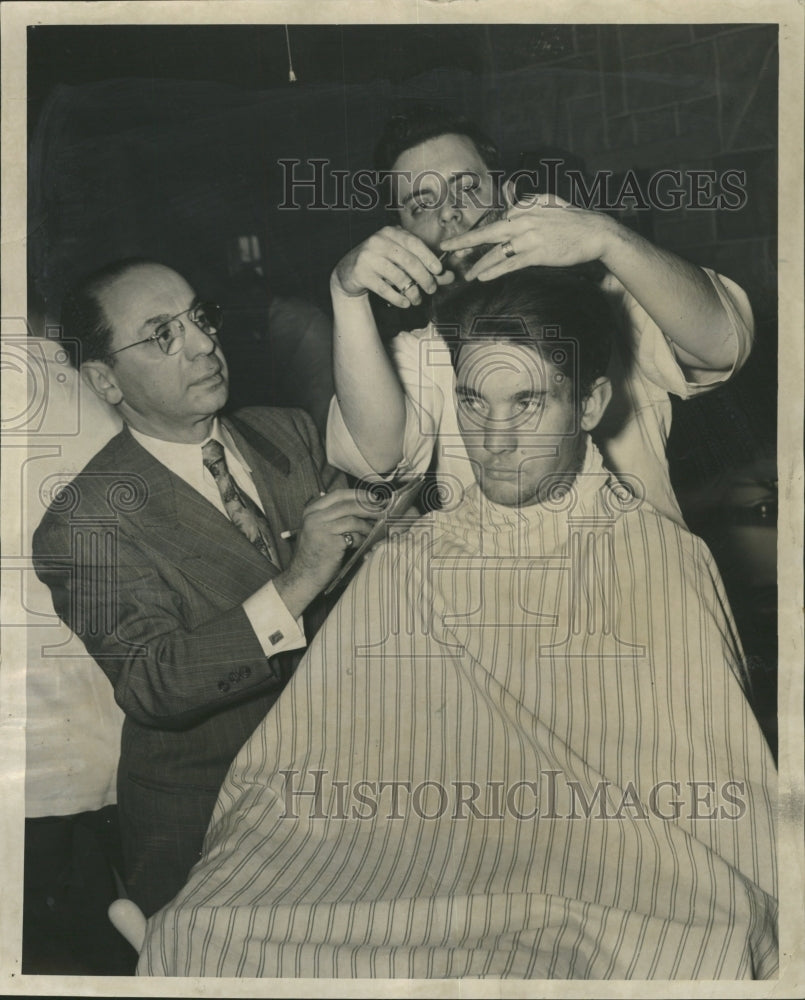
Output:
[33, 260, 378, 914]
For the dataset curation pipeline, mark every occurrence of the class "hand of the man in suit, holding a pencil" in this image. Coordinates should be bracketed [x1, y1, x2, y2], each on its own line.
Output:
[274, 490, 382, 618]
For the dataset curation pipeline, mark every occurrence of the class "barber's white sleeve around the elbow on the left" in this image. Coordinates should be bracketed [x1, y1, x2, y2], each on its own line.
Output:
[327, 328, 446, 479]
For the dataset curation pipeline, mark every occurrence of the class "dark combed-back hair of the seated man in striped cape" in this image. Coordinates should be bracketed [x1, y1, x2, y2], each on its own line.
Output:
[434, 267, 617, 399]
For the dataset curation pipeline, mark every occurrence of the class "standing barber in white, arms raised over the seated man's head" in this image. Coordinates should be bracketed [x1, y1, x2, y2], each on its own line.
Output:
[327, 108, 753, 524]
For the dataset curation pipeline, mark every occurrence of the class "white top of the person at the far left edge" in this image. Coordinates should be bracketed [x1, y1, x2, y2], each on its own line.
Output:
[18, 337, 123, 817]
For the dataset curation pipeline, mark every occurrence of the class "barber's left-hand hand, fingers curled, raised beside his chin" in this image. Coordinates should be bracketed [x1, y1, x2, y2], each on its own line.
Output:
[333, 226, 455, 309]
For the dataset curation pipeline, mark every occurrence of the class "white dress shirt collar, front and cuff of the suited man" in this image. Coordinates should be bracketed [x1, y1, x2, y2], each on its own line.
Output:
[129, 417, 307, 656]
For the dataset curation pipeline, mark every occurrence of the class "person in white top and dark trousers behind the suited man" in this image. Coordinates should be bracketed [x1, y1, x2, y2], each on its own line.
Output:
[10, 334, 127, 974]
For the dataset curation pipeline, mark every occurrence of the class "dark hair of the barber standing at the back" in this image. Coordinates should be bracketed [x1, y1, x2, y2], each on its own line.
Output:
[374, 104, 500, 172]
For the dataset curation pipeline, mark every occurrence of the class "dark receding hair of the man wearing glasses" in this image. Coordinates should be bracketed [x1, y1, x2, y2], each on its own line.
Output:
[61, 257, 155, 367]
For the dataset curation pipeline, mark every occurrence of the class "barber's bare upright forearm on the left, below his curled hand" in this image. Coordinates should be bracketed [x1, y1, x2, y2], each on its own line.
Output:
[331, 280, 405, 474]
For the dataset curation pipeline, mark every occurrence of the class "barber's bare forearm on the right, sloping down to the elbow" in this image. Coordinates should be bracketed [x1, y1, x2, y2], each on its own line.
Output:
[601, 217, 736, 371]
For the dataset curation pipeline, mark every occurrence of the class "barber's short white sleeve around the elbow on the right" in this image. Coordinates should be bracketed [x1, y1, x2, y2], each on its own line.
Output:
[602, 268, 754, 399]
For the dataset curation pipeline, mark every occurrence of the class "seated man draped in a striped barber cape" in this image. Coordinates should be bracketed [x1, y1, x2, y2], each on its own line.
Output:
[138, 270, 776, 979]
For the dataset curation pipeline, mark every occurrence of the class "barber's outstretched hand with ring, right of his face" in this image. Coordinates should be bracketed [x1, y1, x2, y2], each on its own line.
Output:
[434, 194, 618, 281]
